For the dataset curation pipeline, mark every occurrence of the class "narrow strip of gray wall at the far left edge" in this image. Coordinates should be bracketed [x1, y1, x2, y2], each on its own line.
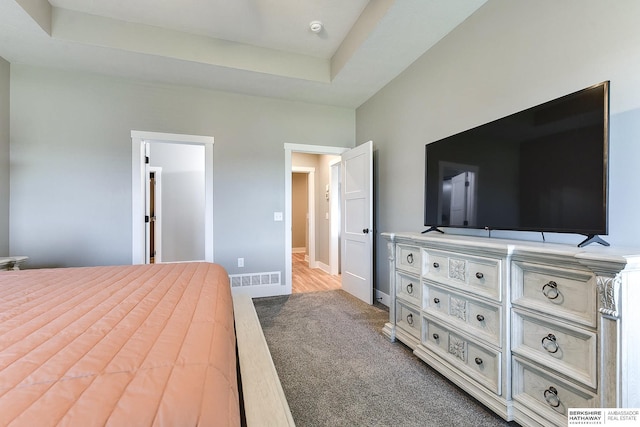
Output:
[0, 58, 10, 257]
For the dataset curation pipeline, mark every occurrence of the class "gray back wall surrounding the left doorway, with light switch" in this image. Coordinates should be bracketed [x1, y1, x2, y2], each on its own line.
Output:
[10, 65, 355, 274]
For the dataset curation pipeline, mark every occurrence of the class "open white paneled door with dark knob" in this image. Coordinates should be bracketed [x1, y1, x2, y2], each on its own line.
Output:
[341, 141, 374, 304]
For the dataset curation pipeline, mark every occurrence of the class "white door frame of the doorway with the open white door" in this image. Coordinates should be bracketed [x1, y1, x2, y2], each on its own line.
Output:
[284, 143, 350, 294]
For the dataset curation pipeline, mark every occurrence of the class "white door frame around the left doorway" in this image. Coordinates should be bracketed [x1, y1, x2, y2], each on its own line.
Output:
[131, 130, 214, 264]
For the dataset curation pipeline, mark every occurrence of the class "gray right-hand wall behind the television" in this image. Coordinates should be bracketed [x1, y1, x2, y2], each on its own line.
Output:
[356, 0, 640, 293]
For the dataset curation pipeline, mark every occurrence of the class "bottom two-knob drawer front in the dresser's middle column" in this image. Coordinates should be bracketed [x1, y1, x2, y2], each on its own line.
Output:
[422, 317, 502, 395]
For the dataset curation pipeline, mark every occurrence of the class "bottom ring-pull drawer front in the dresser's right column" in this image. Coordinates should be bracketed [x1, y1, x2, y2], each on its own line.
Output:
[512, 357, 598, 426]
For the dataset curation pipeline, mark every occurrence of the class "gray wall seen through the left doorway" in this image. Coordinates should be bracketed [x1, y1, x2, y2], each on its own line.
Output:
[149, 142, 205, 262]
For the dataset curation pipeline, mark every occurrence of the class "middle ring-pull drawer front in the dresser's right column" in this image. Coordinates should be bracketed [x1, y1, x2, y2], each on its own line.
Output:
[511, 310, 597, 389]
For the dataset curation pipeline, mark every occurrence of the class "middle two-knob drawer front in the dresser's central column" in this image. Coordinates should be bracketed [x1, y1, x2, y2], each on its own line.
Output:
[422, 282, 502, 347]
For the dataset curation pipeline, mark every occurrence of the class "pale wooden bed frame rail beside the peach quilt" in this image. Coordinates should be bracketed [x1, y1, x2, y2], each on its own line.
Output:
[233, 293, 295, 427]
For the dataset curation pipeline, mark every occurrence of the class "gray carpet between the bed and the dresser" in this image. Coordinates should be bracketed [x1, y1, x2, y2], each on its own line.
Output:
[254, 290, 515, 427]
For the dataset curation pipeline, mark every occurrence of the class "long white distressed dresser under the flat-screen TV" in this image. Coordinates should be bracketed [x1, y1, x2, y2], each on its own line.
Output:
[383, 233, 640, 426]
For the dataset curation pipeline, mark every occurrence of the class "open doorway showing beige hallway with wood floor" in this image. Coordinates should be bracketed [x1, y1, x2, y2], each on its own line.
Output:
[290, 152, 341, 293]
